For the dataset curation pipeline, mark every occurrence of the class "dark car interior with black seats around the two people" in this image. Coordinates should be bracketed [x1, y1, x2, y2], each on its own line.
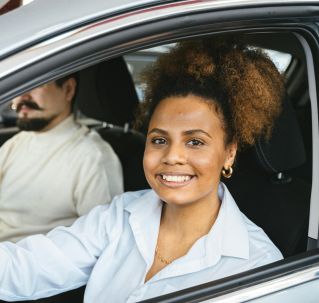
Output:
[0, 32, 312, 302]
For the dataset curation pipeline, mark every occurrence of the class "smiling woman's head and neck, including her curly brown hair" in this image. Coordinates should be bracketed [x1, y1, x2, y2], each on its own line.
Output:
[139, 38, 284, 279]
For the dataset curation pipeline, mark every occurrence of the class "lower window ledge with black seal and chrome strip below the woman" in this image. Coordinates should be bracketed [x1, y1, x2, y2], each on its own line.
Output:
[140, 249, 319, 303]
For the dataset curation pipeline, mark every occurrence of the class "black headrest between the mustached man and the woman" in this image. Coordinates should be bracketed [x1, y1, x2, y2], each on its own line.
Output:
[75, 57, 138, 126]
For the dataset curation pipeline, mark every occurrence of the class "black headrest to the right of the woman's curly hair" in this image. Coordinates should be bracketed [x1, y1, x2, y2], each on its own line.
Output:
[255, 98, 306, 173]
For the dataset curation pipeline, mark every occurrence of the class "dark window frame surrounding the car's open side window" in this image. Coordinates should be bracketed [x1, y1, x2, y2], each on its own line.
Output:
[0, 1, 319, 302]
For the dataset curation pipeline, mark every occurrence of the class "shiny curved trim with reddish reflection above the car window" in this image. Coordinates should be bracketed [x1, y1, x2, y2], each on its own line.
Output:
[0, 0, 318, 80]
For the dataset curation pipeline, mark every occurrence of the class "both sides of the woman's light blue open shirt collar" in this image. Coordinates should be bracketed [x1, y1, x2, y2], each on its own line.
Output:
[125, 183, 249, 278]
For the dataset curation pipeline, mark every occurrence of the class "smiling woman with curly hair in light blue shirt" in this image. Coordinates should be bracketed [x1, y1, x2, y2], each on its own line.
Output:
[0, 39, 284, 302]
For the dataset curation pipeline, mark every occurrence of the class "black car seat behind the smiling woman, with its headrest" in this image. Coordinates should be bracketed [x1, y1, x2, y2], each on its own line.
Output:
[225, 98, 311, 256]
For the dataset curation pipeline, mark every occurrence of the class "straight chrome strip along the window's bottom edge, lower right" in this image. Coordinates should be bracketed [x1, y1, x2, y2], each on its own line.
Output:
[201, 265, 319, 303]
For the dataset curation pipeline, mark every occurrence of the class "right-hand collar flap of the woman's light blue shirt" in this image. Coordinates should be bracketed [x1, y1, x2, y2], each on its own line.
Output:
[166, 183, 249, 278]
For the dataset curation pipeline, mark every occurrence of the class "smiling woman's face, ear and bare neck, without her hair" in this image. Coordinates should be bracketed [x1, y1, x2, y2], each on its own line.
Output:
[144, 95, 237, 279]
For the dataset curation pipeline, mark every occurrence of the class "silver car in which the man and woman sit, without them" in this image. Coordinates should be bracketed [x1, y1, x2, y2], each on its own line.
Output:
[0, 0, 319, 303]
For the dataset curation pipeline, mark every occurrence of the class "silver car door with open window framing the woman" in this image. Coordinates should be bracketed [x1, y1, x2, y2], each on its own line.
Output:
[0, 0, 319, 302]
